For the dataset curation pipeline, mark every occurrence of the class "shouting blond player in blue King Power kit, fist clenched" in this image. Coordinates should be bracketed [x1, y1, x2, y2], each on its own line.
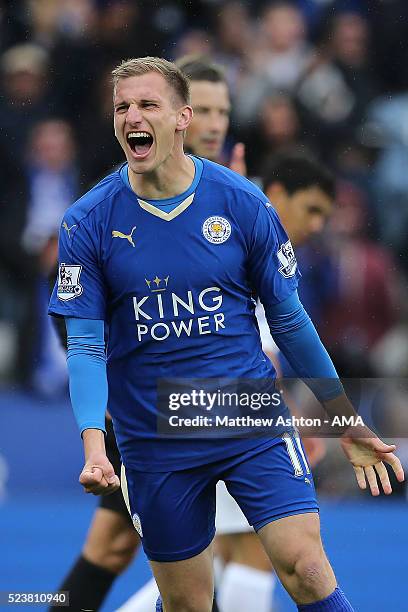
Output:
[50, 58, 403, 612]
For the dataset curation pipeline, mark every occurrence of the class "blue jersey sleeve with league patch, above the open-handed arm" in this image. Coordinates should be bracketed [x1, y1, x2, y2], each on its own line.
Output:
[248, 201, 300, 306]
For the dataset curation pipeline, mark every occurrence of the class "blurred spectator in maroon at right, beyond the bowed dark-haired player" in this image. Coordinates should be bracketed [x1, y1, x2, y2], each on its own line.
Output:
[321, 183, 400, 376]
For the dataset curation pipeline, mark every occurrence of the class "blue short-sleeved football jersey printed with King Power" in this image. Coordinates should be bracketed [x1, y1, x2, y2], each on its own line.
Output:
[50, 157, 298, 471]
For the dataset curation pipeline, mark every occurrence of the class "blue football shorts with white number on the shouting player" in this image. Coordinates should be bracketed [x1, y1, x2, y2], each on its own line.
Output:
[122, 433, 319, 561]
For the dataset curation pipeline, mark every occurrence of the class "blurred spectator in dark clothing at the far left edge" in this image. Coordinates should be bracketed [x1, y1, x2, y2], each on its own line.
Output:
[0, 43, 56, 381]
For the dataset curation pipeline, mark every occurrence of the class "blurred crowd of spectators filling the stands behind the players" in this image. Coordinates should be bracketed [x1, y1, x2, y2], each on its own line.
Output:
[0, 0, 408, 492]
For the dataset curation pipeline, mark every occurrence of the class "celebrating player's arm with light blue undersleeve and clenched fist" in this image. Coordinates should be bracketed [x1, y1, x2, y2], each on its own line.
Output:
[49, 208, 119, 495]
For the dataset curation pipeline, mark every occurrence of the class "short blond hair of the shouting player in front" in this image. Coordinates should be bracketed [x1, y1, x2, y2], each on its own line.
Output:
[112, 57, 190, 104]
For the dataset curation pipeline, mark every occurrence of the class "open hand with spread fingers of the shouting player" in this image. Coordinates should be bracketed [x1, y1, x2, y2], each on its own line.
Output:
[341, 427, 404, 496]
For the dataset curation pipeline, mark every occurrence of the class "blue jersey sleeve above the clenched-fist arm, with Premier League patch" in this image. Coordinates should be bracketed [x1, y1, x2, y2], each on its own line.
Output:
[48, 213, 106, 320]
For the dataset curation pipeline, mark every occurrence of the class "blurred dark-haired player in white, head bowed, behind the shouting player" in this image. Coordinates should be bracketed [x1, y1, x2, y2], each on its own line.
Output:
[216, 152, 334, 612]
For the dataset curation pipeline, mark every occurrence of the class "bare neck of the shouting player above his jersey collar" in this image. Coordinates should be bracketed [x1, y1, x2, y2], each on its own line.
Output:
[128, 151, 195, 200]
